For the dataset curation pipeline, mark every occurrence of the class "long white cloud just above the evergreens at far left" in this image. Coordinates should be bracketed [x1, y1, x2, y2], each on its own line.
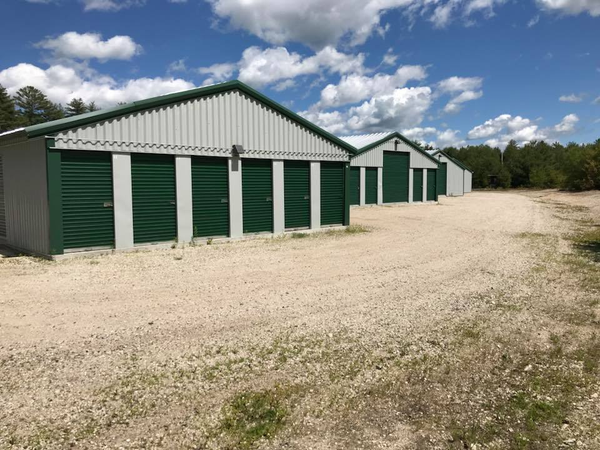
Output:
[0, 63, 194, 107]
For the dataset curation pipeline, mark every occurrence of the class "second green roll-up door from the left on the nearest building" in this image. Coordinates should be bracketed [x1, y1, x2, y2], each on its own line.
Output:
[131, 153, 177, 244]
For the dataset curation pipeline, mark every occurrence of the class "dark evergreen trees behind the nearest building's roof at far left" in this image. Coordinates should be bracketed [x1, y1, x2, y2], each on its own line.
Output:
[0, 84, 100, 133]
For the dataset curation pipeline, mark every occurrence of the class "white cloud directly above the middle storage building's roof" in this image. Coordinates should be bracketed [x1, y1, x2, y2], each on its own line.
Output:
[300, 87, 432, 135]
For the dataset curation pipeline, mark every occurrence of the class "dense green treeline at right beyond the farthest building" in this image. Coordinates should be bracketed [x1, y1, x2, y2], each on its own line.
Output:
[436, 139, 600, 191]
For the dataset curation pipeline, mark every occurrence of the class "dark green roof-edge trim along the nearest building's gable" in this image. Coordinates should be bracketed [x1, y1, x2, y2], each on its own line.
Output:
[19, 80, 358, 154]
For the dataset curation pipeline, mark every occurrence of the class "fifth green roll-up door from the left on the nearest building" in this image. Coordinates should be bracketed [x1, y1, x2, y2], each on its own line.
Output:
[283, 161, 310, 229]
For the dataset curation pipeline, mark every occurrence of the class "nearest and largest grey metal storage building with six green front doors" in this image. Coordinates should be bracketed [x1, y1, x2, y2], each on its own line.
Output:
[0, 81, 356, 256]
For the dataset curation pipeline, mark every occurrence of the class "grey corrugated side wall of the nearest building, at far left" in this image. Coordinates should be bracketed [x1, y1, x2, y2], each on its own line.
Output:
[0, 138, 50, 253]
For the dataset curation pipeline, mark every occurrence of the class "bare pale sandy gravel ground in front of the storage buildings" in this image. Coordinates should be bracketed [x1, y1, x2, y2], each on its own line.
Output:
[0, 192, 600, 448]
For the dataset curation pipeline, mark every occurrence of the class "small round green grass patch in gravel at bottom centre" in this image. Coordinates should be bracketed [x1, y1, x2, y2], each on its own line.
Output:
[219, 387, 289, 450]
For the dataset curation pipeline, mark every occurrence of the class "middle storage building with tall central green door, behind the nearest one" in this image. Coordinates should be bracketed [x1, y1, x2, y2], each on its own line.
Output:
[341, 132, 438, 206]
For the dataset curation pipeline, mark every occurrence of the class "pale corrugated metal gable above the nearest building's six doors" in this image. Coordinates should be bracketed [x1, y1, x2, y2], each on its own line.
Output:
[56, 91, 349, 161]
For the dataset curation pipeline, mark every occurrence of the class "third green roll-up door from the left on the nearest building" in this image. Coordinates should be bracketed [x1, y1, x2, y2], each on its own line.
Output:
[192, 157, 229, 237]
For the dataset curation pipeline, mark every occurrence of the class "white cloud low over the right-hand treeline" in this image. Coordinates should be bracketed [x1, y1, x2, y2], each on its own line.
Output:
[467, 114, 579, 148]
